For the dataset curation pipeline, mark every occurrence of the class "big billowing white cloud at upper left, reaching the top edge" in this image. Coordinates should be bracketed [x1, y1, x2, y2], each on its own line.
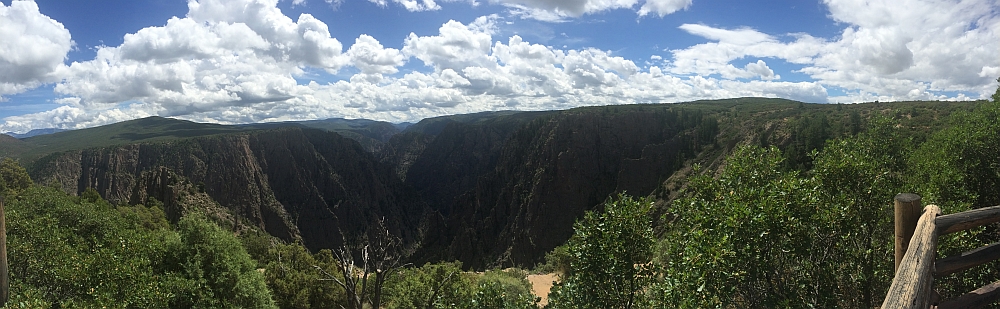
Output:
[55, 0, 352, 116]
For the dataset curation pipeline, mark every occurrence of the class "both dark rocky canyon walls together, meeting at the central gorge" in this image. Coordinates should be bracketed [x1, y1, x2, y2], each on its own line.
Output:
[31, 106, 716, 268]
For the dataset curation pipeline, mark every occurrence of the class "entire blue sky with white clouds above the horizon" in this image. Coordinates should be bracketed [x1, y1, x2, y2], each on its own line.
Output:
[0, 0, 1000, 133]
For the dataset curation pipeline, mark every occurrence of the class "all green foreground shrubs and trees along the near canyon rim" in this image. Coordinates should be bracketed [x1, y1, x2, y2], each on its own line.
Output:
[0, 83, 1000, 308]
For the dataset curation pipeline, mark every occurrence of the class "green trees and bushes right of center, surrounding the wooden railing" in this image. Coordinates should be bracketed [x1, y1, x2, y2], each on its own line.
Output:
[549, 83, 1000, 308]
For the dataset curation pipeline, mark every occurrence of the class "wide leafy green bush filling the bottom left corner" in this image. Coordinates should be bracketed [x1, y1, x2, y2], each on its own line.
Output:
[6, 187, 176, 308]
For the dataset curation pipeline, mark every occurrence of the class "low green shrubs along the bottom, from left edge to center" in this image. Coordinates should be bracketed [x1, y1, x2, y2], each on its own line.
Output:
[0, 159, 537, 308]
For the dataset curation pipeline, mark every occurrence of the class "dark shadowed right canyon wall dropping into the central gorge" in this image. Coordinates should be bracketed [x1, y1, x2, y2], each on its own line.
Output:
[406, 107, 716, 268]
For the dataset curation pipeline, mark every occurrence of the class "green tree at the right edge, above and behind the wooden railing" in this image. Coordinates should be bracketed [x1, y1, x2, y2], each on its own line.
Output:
[907, 82, 1000, 298]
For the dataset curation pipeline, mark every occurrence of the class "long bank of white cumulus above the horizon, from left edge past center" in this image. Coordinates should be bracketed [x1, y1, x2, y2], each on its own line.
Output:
[0, 9, 825, 131]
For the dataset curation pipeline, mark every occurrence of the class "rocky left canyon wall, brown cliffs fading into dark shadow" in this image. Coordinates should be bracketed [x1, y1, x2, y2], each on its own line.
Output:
[32, 128, 426, 249]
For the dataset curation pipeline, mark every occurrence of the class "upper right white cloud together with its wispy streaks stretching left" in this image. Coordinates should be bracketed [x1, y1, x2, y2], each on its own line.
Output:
[668, 0, 1000, 102]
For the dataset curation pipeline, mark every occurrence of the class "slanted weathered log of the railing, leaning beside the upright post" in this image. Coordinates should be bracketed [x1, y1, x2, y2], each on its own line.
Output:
[882, 205, 941, 309]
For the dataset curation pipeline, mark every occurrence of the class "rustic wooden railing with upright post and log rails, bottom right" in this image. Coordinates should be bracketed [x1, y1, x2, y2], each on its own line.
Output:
[882, 193, 1000, 309]
